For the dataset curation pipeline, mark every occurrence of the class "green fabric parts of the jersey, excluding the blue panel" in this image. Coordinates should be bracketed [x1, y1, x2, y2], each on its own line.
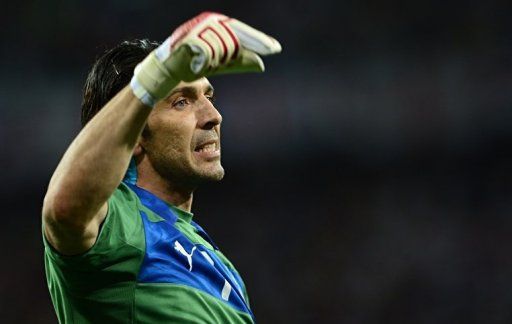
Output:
[43, 184, 252, 323]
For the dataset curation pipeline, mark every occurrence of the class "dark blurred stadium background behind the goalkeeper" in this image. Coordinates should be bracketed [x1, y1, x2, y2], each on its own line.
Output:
[0, 0, 512, 323]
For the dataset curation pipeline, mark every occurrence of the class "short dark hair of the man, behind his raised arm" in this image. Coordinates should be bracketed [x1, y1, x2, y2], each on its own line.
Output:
[81, 39, 159, 126]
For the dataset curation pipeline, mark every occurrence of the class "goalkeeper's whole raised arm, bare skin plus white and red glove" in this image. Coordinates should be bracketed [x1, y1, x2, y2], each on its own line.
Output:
[43, 12, 281, 255]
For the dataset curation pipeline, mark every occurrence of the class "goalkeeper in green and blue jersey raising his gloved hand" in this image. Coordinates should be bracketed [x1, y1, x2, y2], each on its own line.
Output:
[43, 12, 281, 323]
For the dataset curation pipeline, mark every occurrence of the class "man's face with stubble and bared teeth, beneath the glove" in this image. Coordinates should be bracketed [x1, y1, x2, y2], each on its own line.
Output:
[141, 78, 224, 187]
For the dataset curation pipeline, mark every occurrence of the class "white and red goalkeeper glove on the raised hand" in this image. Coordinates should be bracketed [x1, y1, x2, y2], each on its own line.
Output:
[130, 12, 281, 106]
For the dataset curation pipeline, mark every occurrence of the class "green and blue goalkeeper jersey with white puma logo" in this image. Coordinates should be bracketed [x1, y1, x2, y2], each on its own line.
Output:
[44, 183, 254, 323]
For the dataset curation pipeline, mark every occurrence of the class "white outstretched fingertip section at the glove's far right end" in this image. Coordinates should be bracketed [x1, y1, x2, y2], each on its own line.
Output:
[226, 19, 281, 55]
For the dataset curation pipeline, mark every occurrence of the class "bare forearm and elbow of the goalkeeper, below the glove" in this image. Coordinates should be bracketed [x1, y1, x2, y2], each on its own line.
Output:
[43, 86, 151, 254]
